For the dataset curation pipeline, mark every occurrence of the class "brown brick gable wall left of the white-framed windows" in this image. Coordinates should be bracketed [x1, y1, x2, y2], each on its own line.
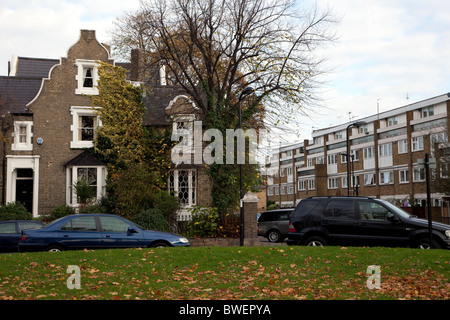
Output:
[29, 30, 113, 214]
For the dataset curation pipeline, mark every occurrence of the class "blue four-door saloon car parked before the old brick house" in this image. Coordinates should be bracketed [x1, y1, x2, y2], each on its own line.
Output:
[19, 214, 190, 252]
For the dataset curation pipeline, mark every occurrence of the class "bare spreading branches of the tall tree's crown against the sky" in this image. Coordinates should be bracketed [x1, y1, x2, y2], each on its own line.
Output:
[113, 0, 336, 131]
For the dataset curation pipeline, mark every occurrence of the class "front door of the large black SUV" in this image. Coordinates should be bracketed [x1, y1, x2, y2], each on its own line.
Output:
[358, 199, 408, 246]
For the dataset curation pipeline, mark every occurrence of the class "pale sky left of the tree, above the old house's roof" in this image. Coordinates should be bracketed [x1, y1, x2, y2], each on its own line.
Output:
[0, 0, 139, 75]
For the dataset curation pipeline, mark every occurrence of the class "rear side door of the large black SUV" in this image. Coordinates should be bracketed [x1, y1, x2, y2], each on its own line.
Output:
[321, 199, 358, 245]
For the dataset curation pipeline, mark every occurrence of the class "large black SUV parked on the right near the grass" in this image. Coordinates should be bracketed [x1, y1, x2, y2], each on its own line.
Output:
[287, 197, 450, 249]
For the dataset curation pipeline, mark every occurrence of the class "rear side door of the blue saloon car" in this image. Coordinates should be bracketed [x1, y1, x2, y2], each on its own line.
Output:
[56, 215, 102, 250]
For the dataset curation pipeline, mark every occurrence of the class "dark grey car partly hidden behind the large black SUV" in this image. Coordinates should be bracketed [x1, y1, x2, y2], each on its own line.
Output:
[258, 209, 294, 242]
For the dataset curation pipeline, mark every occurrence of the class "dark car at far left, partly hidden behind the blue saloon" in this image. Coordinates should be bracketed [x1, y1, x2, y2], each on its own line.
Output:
[0, 220, 44, 252]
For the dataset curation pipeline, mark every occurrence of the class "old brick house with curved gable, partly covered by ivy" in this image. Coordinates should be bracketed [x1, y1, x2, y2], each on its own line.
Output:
[0, 30, 211, 217]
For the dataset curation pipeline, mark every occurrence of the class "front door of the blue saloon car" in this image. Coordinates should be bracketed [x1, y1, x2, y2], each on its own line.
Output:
[99, 216, 143, 248]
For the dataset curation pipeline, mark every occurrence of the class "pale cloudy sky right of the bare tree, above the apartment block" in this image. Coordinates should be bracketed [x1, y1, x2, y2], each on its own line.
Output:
[298, 0, 450, 136]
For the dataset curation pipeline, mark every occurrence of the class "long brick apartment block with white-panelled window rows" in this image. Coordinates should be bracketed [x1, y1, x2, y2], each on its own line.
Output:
[267, 93, 450, 211]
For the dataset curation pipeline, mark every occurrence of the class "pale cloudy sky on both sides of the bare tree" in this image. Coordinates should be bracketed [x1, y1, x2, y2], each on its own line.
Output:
[0, 0, 450, 143]
